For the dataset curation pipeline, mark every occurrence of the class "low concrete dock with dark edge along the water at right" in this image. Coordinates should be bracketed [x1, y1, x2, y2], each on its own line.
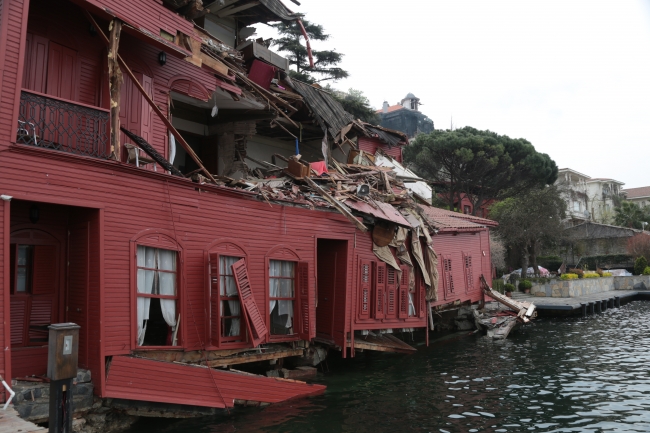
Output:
[512, 290, 650, 315]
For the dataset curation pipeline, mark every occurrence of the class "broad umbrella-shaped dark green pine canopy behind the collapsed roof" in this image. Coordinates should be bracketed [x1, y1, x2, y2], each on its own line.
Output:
[404, 126, 558, 213]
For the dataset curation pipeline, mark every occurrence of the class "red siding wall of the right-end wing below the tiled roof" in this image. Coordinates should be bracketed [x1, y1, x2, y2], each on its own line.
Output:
[432, 229, 491, 306]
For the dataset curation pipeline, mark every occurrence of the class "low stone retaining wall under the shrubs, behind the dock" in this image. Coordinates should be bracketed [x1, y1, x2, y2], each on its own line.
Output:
[530, 275, 650, 298]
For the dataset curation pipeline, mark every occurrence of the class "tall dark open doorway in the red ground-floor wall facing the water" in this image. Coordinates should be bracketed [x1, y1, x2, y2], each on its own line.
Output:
[316, 239, 348, 341]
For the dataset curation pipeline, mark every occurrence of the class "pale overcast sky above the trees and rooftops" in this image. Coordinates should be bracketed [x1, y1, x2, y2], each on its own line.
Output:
[256, 0, 650, 188]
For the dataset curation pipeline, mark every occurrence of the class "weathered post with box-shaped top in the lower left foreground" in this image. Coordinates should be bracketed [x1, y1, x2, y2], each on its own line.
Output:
[47, 323, 80, 433]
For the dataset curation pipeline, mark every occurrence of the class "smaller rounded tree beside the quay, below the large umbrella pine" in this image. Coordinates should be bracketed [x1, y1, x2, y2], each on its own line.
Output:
[490, 185, 566, 278]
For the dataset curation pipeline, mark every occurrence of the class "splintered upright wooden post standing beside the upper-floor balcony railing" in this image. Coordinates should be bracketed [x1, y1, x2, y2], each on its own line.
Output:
[108, 18, 124, 161]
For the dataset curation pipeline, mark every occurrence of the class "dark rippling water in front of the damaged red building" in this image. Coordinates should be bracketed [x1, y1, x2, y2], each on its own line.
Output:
[125, 302, 650, 433]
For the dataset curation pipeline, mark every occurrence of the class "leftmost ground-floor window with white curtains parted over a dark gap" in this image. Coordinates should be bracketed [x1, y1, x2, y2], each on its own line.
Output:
[137, 245, 180, 346]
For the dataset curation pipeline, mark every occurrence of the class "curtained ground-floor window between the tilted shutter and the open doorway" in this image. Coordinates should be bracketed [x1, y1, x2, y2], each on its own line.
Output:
[269, 260, 296, 335]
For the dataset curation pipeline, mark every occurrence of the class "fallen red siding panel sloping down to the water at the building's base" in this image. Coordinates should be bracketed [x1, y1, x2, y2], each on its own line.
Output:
[105, 356, 325, 408]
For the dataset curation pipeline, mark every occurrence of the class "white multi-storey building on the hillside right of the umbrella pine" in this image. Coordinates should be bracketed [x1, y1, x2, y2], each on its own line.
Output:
[556, 168, 625, 224]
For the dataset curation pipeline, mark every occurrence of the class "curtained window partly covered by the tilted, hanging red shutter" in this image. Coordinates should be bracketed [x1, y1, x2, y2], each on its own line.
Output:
[219, 256, 246, 342]
